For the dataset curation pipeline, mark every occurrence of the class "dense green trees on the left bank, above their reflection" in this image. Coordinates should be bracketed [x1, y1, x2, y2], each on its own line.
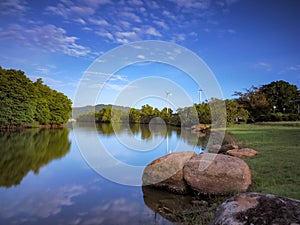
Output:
[0, 67, 72, 128]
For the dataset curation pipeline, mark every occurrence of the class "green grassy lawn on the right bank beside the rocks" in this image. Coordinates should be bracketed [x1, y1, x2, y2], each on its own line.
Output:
[227, 122, 300, 199]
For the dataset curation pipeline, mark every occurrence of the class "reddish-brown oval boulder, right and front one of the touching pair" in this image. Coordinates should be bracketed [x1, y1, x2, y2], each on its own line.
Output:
[183, 153, 251, 195]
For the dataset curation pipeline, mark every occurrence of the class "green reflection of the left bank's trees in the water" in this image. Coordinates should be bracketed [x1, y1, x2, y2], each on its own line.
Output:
[0, 129, 71, 187]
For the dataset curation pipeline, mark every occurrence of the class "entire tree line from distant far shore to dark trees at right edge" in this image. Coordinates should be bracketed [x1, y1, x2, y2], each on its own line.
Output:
[77, 80, 300, 126]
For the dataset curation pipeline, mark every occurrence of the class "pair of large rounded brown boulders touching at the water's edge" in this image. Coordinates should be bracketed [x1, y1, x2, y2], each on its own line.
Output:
[142, 152, 251, 195]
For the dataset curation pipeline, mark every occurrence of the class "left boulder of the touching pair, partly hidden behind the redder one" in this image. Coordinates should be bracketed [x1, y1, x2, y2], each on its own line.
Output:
[142, 152, 196, 194]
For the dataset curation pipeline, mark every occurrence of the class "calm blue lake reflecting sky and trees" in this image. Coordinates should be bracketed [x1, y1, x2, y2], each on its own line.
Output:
[0, 124, 212, 225]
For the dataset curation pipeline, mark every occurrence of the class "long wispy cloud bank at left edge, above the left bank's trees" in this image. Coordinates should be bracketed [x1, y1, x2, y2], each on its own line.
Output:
[0, 24, 91, 56]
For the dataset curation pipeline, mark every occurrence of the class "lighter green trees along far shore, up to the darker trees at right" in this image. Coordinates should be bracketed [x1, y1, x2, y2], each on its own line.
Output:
[77, 99, 248, 127]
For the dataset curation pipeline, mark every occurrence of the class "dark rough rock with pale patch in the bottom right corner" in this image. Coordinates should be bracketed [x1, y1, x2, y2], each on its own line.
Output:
[210, 192, 300, 225]
